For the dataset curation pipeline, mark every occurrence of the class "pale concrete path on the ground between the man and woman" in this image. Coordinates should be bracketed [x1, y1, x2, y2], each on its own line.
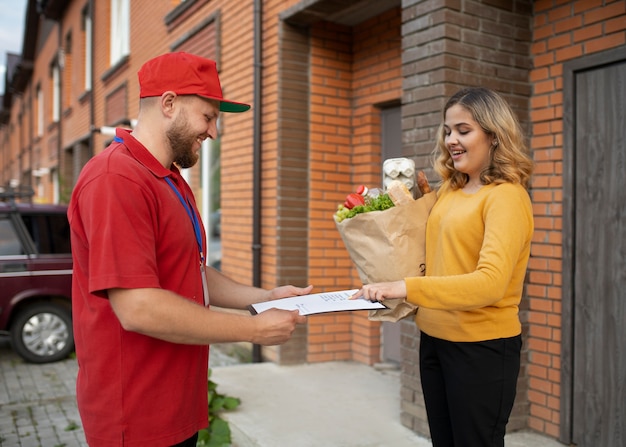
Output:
[212, 362, 563, 447]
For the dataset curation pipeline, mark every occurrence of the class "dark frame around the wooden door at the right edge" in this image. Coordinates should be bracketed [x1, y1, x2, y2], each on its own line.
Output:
[559, 46, 626, 444]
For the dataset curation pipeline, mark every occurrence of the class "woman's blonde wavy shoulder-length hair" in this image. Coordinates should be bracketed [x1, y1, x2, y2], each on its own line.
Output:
[433, 87, 534, 189]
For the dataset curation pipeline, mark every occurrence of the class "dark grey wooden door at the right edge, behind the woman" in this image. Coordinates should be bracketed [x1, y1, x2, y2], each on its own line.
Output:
[563, 45, 626, 447]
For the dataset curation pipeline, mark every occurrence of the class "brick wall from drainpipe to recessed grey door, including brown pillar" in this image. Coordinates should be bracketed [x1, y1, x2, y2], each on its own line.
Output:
[262, 2, 401, 364]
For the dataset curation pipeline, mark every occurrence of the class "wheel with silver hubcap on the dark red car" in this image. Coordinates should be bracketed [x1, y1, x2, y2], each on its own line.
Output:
[11, 303, 74, 363]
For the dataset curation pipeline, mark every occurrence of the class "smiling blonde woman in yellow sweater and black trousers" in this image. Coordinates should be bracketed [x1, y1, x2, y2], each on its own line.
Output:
[355, 88, 533, 447]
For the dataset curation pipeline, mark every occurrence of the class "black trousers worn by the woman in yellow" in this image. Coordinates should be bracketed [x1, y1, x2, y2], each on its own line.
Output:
[420, 332, 522, 447]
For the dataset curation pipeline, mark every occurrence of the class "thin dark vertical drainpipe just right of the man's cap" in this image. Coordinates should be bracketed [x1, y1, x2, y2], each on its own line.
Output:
[252, 0, 263, 363]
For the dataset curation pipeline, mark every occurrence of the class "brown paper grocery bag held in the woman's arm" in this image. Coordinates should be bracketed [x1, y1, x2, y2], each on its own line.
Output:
[336, 191, 437, 322]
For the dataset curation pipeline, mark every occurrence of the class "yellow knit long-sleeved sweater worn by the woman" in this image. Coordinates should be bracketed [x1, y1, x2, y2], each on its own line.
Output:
[405, 183, 533, 342]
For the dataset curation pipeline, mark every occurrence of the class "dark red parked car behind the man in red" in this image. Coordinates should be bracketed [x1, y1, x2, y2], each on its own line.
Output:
[0, 194, 74, 363]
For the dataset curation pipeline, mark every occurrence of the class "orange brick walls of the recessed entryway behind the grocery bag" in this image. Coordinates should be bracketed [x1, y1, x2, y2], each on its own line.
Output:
[308, 9, 401, 364]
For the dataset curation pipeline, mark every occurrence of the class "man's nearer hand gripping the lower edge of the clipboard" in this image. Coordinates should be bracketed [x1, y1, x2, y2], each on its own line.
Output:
[251, 309, 306, 346]
